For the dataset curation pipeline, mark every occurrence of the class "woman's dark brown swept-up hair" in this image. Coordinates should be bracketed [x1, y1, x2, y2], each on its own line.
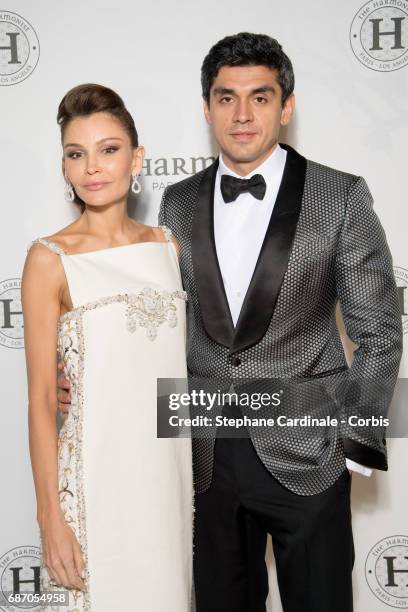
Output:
[57, 83, 139, 210]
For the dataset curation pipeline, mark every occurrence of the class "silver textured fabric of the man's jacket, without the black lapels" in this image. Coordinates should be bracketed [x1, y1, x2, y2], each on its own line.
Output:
[160, 147, 402, 495]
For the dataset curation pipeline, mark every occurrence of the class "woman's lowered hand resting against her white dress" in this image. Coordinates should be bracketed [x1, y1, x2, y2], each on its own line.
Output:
[40, 514, 85, 591]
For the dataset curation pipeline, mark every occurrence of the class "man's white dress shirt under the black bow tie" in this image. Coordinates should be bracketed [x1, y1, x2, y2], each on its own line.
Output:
[214, 145, 372, 476]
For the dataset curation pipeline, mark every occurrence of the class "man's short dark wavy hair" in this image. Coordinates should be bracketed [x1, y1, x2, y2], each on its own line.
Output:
[201, 32, 295, 104]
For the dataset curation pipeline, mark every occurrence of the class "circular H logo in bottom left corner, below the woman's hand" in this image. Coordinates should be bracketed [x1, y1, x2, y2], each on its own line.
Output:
[0, 546, 40, 612]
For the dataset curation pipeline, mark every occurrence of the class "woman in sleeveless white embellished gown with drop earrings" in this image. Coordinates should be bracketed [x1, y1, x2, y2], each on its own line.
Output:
[22, 84, 193, 612]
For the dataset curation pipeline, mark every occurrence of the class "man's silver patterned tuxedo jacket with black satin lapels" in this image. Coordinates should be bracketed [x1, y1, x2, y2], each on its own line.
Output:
[160, 145, 402, 495]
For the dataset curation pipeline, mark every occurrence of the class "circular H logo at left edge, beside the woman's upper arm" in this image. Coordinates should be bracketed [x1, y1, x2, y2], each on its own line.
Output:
[0, 278, 24, 348]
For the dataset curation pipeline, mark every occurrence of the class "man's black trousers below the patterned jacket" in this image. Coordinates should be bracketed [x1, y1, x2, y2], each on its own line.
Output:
[194, 416, 354, 612]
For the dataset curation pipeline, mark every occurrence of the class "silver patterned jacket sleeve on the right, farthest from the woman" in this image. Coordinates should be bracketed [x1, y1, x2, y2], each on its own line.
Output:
[336, 177, 402, 470]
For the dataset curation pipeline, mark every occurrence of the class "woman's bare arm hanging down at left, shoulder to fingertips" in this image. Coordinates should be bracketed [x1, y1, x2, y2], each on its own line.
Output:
[22, 245, 84, 589]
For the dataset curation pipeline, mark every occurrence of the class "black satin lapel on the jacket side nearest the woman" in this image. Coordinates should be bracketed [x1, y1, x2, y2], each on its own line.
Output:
[191, 160, 234, 347]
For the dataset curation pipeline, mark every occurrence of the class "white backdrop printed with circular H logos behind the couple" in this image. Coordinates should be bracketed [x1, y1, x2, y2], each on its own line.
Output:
[0, 0, 408, 612]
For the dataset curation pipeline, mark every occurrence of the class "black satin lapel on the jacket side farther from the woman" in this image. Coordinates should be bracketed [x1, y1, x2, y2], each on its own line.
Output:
[230, 145, 306, 353]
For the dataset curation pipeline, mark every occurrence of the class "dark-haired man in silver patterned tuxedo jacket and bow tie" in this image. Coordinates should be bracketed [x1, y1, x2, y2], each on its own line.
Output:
[59, 33, 402, 612]
